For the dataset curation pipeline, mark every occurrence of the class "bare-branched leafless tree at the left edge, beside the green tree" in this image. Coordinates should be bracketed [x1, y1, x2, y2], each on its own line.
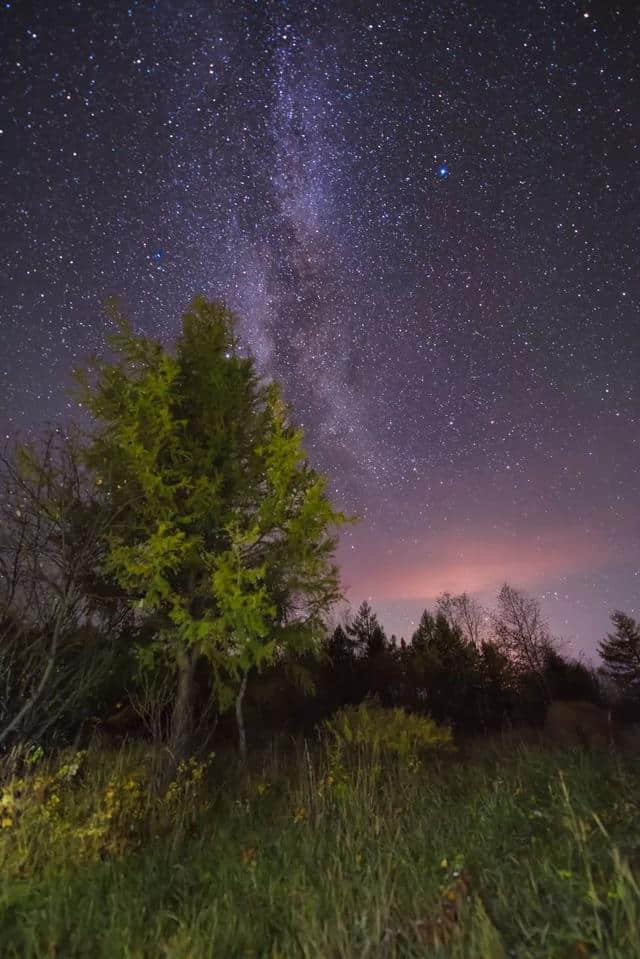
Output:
[0, 429, 125, 746]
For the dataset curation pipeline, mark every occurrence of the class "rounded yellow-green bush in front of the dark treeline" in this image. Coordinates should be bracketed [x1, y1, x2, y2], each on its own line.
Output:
[323, 701, 453, 763]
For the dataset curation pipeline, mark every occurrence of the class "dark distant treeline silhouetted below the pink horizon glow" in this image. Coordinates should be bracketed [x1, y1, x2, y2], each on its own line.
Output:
[236, 585, 640, 748]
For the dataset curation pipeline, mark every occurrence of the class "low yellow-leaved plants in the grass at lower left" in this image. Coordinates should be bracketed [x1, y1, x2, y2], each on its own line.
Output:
[0, 751, 213, 877]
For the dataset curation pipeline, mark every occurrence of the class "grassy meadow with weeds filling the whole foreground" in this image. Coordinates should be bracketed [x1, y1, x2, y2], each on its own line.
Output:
[0, 746, 640, 959]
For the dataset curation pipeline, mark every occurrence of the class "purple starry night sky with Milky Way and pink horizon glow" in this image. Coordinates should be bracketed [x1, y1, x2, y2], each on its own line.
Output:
[0, 0, 640, 654]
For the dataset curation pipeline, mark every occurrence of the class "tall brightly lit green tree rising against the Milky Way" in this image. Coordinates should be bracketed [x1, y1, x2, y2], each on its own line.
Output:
[79, 297, 345, 756]
